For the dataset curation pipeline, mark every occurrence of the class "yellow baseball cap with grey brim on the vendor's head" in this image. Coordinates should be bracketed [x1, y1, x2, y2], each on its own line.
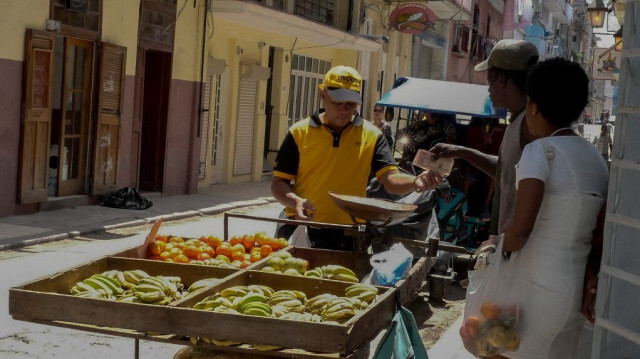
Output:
[320, 65, 362, 105]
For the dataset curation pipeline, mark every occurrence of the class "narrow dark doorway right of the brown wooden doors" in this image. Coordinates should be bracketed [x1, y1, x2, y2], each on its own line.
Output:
[138, 50, 172, 192]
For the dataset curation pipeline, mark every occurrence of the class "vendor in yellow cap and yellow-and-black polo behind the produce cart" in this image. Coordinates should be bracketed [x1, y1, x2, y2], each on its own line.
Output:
[271, 66, 435, 250]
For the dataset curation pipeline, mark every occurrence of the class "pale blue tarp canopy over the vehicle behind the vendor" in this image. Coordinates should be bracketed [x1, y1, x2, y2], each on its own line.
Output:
[378, 77, 506, 117]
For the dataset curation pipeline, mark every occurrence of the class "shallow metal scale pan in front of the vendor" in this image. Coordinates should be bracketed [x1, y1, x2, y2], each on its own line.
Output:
[329, 192, 418, 225]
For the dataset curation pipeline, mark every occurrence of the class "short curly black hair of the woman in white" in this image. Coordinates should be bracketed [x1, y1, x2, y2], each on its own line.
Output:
[527, 57, 589, 127]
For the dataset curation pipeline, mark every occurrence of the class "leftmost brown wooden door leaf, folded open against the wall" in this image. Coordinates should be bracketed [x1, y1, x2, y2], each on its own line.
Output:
[18, 29, 55, 203]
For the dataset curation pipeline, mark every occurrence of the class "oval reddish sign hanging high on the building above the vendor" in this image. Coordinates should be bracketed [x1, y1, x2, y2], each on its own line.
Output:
[389, 3, 436, 34]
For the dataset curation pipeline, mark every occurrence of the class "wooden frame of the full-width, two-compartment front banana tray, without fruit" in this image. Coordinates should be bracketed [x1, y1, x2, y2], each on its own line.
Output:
[9, 257, 397, 354]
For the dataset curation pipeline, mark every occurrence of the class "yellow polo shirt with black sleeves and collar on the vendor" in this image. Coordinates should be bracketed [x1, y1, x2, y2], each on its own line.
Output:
[273, 112, 397, 224]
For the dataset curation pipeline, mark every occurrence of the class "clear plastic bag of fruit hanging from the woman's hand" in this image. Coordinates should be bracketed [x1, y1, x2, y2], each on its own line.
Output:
[460, 237, 521, 357]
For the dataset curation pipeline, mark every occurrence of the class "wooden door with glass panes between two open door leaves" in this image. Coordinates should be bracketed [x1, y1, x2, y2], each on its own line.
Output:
[58, 37, 93, 196]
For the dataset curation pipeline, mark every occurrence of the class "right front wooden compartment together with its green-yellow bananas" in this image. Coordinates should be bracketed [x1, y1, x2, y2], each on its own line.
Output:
[171, 270, 396, 353]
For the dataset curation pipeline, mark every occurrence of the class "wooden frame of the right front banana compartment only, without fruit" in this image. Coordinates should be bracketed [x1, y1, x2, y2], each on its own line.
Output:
[171, 270, 397, 354]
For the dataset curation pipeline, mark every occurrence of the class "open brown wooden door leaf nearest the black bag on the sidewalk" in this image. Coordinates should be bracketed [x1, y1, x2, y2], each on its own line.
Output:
[93, 43, 127, 194]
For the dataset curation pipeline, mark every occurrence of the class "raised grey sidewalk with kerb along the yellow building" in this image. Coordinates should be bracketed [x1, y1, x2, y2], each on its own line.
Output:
[0, 181, 275, 251]
